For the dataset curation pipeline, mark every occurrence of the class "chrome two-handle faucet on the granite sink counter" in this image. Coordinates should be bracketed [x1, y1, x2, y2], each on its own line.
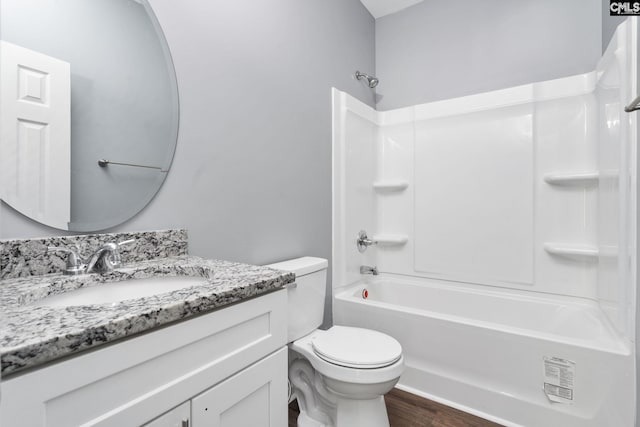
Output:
[47, 239, 135, 275]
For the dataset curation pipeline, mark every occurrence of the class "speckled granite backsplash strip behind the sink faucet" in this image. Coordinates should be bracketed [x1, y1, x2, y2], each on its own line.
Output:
[0, 230, 187, 279]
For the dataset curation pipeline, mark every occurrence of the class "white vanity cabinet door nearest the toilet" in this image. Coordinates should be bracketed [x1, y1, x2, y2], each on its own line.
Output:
[192, 347, 287, 427]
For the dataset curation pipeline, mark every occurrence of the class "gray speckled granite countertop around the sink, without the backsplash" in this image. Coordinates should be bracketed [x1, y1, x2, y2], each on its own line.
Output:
[0, 256, 295, 376]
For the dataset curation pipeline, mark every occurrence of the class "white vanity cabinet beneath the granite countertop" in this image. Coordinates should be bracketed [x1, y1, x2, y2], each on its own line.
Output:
[0, 290, 287, 427]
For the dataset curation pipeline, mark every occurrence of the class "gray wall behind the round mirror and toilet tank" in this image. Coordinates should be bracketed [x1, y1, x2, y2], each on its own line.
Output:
[0, 0, 374, 326]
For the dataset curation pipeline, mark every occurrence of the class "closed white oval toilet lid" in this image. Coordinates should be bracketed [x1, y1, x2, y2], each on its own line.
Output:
[312, 326, 402, 369]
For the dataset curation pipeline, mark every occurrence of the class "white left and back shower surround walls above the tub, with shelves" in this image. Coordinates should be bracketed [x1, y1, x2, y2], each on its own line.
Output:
[334, 65, 620, 299]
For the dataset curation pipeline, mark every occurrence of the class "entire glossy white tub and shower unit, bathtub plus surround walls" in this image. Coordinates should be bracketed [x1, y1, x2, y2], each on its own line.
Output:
[333, 20, 637, 427]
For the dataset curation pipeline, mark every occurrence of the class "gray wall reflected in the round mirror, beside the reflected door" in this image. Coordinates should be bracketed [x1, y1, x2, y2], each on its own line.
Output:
[0, 0, 177, 230]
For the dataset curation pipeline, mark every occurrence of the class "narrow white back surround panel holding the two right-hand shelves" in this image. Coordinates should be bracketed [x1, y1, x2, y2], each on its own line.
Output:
[534, 94, 598, 298]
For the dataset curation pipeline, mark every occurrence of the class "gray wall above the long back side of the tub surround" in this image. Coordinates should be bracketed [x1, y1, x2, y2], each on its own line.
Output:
[376, 0, 602, 110]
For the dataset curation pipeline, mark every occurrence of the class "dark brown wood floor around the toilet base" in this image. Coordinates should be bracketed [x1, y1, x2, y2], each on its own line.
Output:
[289, 388, 501, 427]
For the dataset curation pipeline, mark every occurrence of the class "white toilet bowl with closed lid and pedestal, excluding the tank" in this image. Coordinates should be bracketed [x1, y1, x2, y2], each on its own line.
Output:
[289, 326, 404, 427]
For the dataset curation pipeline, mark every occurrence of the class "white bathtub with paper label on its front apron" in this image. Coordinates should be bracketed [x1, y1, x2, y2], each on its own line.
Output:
[333, 275, 635, 427]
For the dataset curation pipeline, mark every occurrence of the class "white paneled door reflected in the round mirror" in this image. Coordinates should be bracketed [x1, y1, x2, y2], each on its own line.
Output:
[0, 41, 71, 229]
